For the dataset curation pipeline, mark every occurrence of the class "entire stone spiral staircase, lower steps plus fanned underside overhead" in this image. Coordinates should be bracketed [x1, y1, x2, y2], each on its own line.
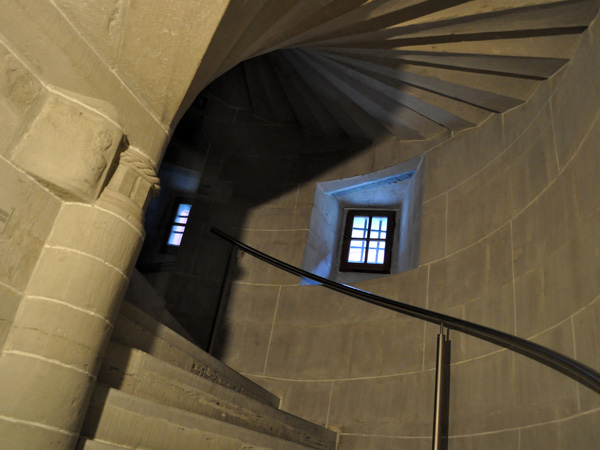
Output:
[80, 0, 599, 450]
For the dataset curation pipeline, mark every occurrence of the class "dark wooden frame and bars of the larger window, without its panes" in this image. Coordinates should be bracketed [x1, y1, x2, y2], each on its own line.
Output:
[339, 209, 397, 274]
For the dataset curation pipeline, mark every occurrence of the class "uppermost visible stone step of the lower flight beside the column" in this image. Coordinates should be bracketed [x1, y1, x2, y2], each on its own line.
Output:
[111, 302, 279, 406]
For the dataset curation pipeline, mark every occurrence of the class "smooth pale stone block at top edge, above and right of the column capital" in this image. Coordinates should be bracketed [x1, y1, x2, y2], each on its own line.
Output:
[116, 1, 230, 124]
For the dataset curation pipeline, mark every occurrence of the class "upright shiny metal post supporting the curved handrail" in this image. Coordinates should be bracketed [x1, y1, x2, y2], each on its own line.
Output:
[432, 323, 450, 450]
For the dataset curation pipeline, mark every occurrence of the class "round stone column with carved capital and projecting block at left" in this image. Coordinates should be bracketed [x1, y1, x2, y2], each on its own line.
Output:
[0, 92, 158, 450]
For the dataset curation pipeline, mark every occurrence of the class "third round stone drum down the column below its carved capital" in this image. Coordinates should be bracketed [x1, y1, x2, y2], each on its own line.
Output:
[5, 297, 112, 374]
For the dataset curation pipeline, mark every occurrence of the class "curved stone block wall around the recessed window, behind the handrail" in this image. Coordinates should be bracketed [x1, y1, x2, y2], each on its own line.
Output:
[193, 12, 600, 450]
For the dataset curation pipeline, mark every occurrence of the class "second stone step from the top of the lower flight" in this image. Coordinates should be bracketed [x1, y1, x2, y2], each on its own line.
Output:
[98, 343, 336, 450]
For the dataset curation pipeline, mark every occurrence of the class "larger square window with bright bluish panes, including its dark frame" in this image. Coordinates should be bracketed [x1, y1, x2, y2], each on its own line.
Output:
[340, 210, 396, 273]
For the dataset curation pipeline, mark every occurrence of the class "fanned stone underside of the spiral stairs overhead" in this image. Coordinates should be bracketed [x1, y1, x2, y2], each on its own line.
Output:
[196, 0, 598, 140]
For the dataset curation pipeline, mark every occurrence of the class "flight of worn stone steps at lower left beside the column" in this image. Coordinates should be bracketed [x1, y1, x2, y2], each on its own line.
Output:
[78, 302, 337, 450]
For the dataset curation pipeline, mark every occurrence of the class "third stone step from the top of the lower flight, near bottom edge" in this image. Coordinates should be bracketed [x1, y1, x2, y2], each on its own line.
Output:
[81, 383, 324, 450]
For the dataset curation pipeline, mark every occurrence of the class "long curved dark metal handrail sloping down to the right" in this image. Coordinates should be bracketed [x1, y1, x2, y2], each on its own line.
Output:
[211, 227, 600, 394]
